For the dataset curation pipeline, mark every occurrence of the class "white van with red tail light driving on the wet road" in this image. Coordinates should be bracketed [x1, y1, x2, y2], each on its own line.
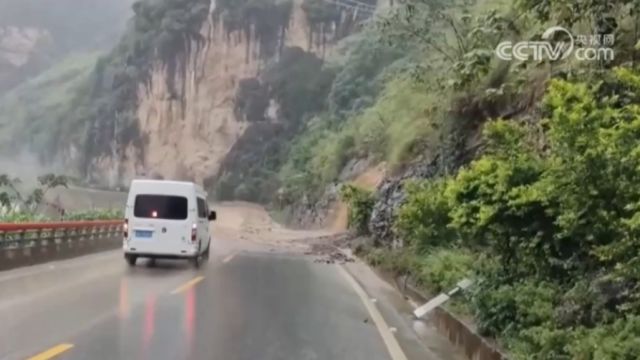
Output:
[122, 180, 216, 267]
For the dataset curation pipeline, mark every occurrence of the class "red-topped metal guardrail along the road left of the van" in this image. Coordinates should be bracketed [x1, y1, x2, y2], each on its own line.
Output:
[0, 220, 123, 249]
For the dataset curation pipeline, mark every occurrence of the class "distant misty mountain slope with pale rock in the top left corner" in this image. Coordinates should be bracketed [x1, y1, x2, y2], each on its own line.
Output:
[0, 0, 133, 94]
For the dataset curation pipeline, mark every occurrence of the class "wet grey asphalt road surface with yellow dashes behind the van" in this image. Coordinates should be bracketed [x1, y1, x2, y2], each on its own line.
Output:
[0, 246, 390, 360]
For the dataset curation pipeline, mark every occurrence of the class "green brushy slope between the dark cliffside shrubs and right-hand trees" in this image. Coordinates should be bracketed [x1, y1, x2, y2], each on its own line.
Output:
[278, 28, 408, 203]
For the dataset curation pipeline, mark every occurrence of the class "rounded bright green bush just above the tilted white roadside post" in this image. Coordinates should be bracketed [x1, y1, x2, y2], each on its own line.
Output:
[447, 134, 552, 276]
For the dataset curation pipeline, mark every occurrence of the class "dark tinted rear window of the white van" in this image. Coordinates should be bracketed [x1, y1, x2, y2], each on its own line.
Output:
[133, 195, 188, 220]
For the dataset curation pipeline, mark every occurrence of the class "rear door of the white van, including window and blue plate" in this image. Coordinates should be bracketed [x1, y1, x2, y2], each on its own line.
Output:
[131, 194, 191, 254]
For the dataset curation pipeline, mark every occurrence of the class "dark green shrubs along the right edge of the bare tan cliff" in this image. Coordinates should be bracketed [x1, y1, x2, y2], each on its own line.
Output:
[215, 47, 334, 203]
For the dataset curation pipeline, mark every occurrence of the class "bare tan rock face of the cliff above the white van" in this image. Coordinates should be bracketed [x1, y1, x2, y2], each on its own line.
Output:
[91, 1, 358, 186]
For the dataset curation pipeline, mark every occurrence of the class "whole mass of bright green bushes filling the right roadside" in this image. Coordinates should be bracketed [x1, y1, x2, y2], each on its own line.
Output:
[380, 67, 640, 359]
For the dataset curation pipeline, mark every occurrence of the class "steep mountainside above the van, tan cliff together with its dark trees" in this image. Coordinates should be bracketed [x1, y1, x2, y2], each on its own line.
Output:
[69, 0, 378, 186]
